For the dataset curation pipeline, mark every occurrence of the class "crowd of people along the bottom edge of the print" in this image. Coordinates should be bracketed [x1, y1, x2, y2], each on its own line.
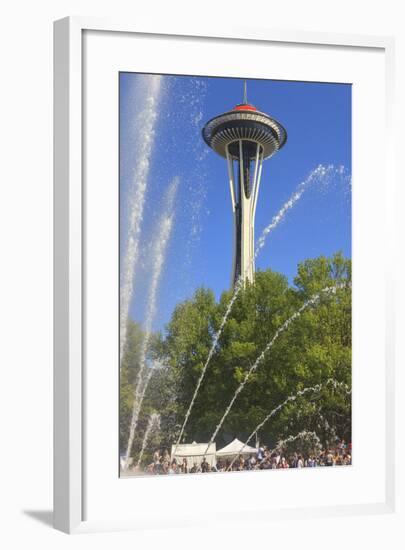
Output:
[137, 440, 352, 475]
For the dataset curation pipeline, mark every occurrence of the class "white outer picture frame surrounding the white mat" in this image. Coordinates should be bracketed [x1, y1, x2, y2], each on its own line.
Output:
[54, 17, 401, 533]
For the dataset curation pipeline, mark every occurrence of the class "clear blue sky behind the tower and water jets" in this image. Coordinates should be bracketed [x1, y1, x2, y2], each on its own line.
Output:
[120, 73, 351, 329]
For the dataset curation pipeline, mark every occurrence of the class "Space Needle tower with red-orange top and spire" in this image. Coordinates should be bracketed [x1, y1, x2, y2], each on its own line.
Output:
[202, 80, 287, 285]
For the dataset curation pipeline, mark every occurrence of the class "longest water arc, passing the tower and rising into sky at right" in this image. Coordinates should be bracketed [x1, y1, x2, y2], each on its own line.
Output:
[171, 164, 344, 460]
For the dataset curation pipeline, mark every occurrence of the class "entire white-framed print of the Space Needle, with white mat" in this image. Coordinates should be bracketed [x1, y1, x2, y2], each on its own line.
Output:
[55, 18, 395, 532]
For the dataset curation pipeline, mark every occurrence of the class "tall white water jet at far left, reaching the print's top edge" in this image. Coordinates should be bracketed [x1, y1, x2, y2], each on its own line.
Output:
[120, 75, 163, 366]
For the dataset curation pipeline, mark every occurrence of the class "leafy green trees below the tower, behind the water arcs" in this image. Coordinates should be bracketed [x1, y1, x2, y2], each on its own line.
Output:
[120, 253, 351, 463]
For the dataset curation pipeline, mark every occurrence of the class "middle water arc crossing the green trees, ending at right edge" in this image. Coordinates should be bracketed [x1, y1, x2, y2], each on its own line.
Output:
[204, 283, 346, 462]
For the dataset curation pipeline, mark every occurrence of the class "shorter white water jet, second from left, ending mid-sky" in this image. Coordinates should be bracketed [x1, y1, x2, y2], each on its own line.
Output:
[125, 177, 179, 468]
